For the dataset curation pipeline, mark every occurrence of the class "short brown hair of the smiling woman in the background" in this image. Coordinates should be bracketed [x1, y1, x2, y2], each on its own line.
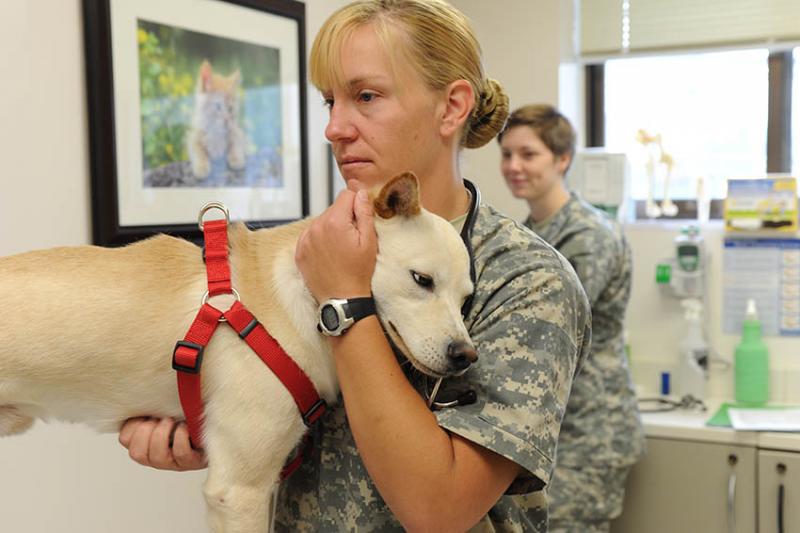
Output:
[497, 104, 576, 160]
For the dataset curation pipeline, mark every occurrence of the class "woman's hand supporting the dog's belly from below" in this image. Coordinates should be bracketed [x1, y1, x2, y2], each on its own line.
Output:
[119, 418, 208, 471]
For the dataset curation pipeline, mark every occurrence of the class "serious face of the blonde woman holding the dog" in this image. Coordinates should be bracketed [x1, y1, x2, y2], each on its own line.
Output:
[323, 25, 444, 191]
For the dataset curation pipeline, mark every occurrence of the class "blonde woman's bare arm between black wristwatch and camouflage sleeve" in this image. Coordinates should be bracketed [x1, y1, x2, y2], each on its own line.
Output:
[332, 317, 518, 531]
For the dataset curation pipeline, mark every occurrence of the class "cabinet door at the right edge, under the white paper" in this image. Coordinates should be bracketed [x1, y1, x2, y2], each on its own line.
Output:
[758, 450, 800, 533]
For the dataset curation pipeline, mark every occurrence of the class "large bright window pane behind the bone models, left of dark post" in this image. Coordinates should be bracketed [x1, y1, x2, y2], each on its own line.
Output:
[602, 49, 768, 200]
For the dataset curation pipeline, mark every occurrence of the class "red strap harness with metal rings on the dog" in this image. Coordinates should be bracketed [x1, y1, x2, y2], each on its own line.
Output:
[172, 211, 326, 479]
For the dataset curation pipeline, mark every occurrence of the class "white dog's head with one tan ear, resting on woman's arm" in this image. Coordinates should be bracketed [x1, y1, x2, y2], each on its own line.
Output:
[371, 172, 477, 377]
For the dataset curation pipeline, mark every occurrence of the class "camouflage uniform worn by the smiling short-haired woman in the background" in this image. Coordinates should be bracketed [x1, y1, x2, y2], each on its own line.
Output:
[525, 193, 644, 531]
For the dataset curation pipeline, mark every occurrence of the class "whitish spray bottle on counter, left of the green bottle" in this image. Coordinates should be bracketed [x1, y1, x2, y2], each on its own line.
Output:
[676, 298, 709, 400]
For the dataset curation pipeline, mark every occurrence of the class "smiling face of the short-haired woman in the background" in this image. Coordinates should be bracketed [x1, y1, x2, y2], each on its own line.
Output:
[500, 126, 569, 201]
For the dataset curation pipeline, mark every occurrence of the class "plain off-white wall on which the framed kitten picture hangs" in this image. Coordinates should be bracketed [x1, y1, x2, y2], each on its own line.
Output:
[0, 0, 343, 533]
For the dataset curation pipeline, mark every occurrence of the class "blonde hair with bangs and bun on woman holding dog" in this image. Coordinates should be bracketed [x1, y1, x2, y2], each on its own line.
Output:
[309, 0, 508, 148]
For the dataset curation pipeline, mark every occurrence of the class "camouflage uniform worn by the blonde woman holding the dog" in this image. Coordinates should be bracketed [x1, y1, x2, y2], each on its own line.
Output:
[276, 198, 591, 532]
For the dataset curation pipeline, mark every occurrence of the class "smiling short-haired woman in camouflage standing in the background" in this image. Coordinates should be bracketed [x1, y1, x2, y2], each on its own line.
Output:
[498, 105, 644, 533]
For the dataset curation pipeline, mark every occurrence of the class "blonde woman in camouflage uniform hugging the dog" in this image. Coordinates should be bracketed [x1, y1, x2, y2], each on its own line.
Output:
[120, 0, 590, 531]
